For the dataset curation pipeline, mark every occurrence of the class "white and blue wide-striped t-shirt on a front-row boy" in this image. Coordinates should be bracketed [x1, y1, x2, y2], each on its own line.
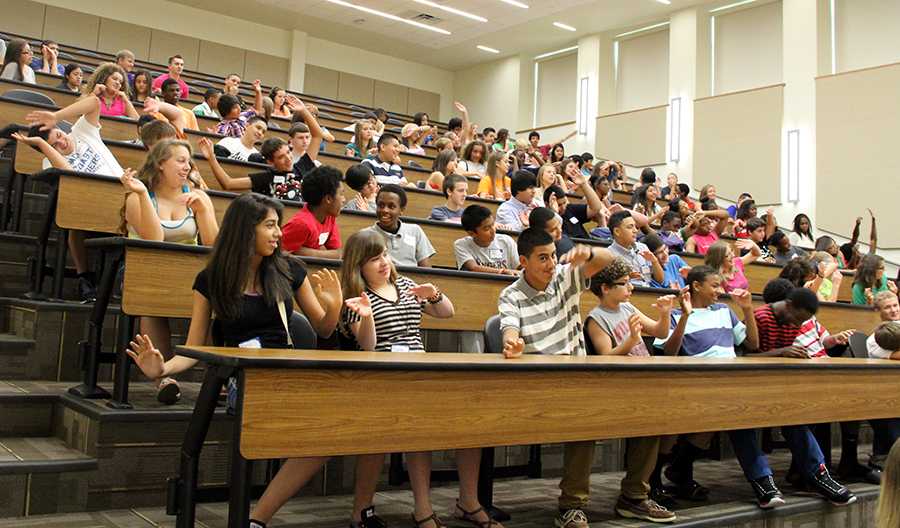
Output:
[653, 303, 747, 359]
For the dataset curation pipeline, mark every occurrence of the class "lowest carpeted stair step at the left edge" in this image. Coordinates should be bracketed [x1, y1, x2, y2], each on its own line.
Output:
[0, 436, 97, 475]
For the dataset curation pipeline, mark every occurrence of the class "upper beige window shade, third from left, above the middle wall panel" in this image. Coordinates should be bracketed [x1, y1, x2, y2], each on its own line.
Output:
[715, 2, 783, 94]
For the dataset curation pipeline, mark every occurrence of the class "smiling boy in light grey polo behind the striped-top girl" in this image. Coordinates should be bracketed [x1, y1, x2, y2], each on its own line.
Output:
[366, 184, 435, 268]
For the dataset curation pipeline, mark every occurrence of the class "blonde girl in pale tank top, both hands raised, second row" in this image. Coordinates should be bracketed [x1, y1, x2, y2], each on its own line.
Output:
[122, 139, 219, 405]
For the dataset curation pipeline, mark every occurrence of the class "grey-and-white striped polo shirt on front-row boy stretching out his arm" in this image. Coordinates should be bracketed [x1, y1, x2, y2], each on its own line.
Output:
[499, 264, 588, 356]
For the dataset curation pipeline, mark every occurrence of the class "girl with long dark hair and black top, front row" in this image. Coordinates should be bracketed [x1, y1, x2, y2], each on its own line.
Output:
[127, 193, 381, 526]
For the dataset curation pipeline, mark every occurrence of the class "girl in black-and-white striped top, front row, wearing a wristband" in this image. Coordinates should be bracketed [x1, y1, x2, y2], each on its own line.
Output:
[339, 231, 503, 528]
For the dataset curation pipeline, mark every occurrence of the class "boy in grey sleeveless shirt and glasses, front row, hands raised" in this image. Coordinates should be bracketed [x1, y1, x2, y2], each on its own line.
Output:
[584, 258, 675, 522]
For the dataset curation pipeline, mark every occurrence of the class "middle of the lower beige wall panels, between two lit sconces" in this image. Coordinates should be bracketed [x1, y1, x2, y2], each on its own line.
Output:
[694, 85, 784, 205]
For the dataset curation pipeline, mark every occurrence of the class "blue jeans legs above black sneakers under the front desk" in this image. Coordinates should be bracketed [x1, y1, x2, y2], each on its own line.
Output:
[728, 425, 825, 480]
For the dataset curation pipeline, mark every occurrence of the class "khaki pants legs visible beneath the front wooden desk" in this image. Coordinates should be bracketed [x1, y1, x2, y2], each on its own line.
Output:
[559, 436, 660, 509]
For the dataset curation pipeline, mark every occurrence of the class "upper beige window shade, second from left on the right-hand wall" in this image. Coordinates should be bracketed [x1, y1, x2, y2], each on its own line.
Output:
[616, 30, 669, 115]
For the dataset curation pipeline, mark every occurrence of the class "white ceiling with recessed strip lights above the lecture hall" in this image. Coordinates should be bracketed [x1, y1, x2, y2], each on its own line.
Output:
[175, 0, 709, 70]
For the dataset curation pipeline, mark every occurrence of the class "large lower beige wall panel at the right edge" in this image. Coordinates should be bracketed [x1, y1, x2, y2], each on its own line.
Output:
[816, 65, 900, 249]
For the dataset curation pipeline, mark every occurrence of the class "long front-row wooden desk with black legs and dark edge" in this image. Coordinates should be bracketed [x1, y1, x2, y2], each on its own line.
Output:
[170, 347, 900, 528]
